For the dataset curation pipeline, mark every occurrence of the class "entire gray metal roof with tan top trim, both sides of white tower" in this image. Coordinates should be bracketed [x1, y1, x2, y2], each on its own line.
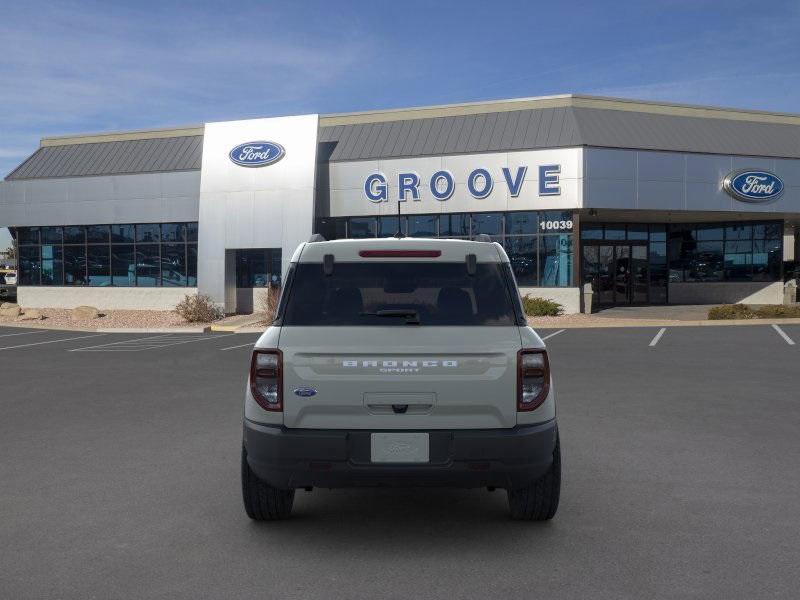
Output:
[7, 96, 800, 179]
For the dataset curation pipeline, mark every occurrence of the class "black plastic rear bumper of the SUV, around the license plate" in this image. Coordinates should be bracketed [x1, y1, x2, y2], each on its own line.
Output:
[244, 419, 558, 489]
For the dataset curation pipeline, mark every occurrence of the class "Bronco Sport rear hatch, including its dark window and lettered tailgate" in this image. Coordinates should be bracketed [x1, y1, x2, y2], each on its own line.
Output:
[278, 243, 521, 429]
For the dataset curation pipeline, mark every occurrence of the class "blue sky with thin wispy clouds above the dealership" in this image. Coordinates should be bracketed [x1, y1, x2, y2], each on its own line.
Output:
[0, 0, 800, 245]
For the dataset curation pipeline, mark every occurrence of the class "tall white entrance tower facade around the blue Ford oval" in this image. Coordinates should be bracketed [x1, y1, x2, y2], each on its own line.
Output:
[198, 115, 318, 311]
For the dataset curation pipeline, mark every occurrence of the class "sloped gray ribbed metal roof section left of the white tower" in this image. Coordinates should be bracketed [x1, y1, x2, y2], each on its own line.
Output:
[6, 135, 203, 179]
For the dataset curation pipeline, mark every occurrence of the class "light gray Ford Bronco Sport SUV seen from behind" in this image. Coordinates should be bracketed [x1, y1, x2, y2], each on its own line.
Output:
[242, 238, 561, 520]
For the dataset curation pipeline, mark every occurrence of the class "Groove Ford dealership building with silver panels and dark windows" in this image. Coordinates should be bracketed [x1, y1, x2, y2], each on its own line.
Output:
[0, 95, 800, 312]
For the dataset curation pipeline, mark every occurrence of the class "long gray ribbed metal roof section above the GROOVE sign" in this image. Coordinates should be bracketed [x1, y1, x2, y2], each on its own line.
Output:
[320, 107, 800, 161]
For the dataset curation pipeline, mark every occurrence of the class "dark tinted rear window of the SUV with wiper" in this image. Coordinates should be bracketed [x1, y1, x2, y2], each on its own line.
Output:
[279, 262, 516, 326]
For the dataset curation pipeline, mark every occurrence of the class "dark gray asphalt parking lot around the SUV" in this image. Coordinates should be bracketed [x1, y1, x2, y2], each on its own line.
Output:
[0, 325, 800, 600]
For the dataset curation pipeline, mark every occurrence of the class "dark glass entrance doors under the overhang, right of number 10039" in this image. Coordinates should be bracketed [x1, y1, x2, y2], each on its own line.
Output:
[583, 242, 649, 306]
